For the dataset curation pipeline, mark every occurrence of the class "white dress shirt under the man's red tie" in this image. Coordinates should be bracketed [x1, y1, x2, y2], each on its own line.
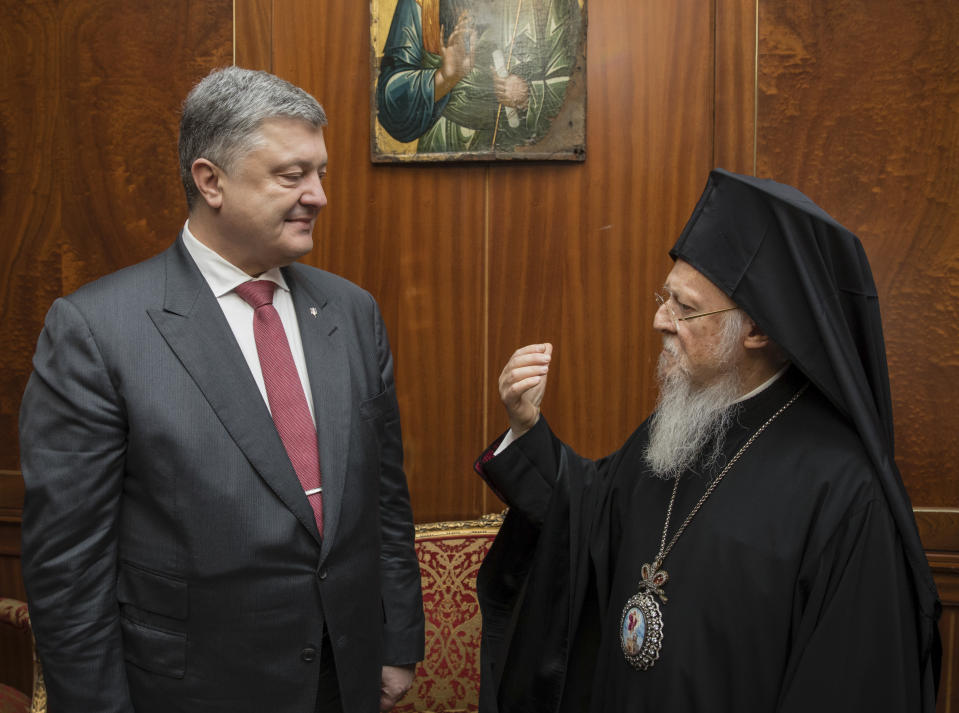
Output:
[183, 221, 316, 424]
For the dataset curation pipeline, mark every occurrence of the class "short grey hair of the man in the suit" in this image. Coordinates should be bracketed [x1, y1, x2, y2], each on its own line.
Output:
[179, 67, 326, 208]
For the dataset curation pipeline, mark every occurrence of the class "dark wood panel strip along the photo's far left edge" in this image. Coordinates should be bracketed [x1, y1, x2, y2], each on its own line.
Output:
[0, 0, 60, 470]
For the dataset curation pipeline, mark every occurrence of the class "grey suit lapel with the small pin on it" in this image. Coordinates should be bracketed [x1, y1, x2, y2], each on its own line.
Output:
[283, 264, 353, 560]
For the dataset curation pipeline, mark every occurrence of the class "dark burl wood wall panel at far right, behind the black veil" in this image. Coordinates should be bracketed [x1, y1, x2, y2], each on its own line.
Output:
[758, 0, 959, 507]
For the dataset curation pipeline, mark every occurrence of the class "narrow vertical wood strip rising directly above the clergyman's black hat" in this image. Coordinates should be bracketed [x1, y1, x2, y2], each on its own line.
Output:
[713, 0, 759, 175]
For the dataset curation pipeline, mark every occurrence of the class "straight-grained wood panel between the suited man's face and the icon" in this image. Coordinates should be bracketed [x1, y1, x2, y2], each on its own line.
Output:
[273, 2, 486, 521]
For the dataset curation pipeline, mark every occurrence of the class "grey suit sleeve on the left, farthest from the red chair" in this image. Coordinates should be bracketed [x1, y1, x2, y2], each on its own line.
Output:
[20, 299, 133, 713]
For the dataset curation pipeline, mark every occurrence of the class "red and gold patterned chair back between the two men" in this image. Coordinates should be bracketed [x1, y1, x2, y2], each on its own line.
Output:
[394, 515, 503, 713]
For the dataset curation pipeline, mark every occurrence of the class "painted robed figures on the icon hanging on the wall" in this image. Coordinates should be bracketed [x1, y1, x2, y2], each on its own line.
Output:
[376, 0, 582, 153]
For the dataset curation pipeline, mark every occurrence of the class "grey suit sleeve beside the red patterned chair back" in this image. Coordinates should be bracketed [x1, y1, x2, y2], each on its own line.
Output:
[373, 294, 425, 666]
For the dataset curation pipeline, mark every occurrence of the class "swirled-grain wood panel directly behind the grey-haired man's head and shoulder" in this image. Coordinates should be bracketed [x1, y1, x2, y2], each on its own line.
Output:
[57, 0, 232, 293]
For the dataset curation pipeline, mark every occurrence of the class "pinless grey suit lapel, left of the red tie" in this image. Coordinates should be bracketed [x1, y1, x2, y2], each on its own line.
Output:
[148, 240, 322, 541]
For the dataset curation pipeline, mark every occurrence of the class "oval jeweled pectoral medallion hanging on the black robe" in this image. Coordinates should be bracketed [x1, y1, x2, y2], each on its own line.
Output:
[619, 562, 669, 671]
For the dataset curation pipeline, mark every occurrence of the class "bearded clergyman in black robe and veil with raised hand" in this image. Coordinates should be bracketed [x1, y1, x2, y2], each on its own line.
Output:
[477, 170, 939, 713]
